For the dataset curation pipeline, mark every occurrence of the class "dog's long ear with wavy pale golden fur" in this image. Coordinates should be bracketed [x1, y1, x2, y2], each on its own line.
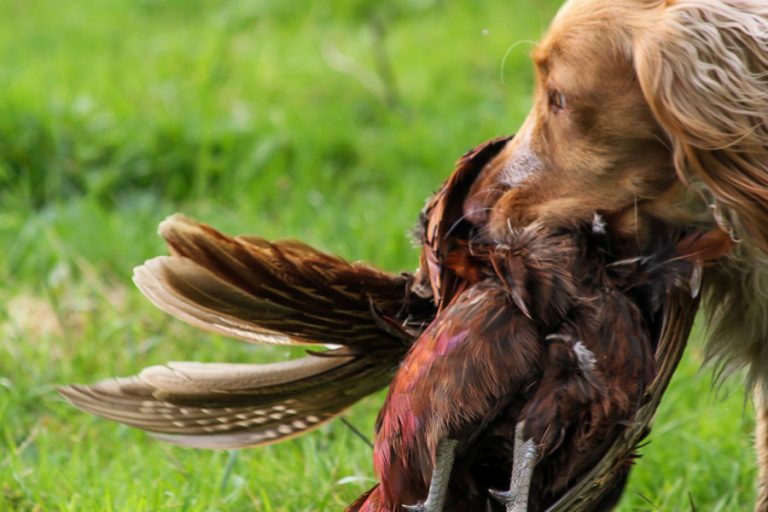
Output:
[634, 0, 768, 252]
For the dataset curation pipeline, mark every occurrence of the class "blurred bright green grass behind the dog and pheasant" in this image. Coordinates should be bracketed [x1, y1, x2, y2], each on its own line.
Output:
[0, 0, 755, 511]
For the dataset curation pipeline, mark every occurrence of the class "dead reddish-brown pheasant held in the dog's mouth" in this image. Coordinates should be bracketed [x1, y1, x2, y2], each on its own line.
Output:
[60, 138, 728, 511]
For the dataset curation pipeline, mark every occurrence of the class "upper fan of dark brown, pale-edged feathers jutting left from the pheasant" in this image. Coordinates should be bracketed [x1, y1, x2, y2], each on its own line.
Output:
[134, 214, 434, 350]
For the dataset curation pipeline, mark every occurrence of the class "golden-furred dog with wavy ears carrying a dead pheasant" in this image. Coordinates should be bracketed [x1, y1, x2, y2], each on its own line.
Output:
[465, 0, 768, 510]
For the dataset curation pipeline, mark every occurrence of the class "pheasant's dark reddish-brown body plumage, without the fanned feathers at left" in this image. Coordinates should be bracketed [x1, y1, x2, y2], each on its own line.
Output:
[349, 139, 727, 512]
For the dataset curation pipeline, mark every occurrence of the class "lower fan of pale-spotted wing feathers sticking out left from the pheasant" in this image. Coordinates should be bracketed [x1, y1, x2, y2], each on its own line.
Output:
[59, 348, 399, 449]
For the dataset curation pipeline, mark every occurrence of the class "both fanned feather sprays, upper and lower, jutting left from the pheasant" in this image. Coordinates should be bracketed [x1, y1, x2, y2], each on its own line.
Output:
[59, 215, 434, 448]
